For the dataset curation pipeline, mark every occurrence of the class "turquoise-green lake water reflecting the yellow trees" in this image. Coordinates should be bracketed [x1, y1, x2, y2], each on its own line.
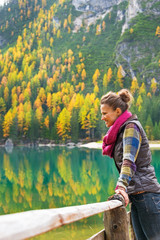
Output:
[0, 147, 160, 240]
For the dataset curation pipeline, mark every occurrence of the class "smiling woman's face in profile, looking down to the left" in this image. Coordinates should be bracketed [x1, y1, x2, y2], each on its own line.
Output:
[101, 104, 122, 127]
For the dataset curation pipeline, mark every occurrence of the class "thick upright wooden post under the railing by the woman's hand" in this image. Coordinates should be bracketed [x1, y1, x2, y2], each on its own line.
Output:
[104, 207, 129, 240]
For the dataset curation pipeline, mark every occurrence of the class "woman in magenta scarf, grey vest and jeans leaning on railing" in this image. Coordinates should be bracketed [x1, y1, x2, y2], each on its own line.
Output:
[101, 89, 160, 240]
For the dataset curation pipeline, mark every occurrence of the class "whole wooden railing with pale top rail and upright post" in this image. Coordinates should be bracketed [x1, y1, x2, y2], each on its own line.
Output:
[0, 200, 134, 240]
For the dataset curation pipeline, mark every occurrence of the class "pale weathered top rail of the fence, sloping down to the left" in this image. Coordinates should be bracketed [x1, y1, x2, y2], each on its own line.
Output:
[0, 200, 122, 240]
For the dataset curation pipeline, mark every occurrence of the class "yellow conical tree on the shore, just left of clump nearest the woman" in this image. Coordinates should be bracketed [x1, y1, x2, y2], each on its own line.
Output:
[56, 108, 71, 141]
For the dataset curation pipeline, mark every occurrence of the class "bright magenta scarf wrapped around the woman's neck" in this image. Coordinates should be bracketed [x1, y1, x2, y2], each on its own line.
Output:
[102, 110, 132, 158]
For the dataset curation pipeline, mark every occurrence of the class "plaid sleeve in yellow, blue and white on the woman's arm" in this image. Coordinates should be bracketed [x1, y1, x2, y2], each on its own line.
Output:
[116, 123, 142, 190]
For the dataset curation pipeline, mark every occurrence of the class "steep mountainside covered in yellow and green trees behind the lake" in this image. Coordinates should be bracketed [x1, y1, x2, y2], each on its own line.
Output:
[0, 0, 160, 142]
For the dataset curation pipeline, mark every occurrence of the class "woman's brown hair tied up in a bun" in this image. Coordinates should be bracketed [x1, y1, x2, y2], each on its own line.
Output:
[101, 89, 133, 112]
